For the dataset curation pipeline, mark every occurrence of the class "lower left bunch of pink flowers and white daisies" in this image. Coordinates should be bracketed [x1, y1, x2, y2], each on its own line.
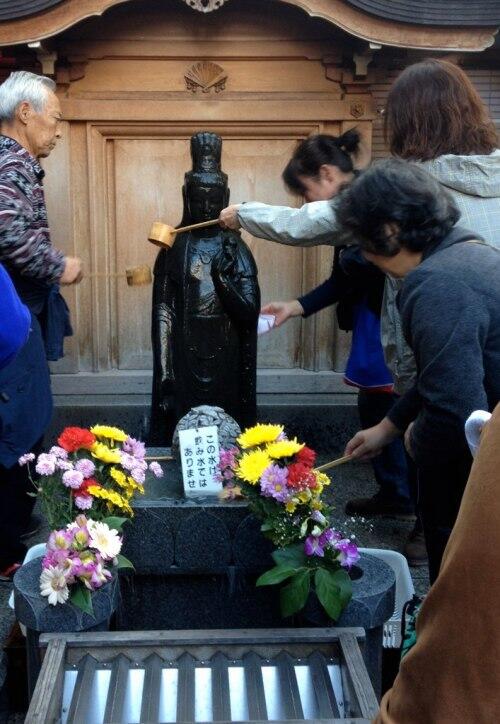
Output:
[40, 514, 128, 615]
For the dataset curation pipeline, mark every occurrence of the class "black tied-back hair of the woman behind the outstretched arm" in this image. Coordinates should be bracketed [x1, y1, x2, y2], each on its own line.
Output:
[282, 128, 361, 195]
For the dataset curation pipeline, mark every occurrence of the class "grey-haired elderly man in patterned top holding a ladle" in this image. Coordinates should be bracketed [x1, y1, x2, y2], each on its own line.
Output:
[0, 71, 81, 578]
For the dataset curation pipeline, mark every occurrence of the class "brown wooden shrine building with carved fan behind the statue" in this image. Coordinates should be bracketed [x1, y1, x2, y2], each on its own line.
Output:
[0, 0, 500, 405]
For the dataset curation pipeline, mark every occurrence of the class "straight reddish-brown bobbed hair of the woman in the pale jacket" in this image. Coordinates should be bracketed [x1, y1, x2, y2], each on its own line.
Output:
[384, 59, 498, 161]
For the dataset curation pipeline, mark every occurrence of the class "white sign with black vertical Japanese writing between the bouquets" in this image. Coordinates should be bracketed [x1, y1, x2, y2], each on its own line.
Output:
[179, 425, 222, 497]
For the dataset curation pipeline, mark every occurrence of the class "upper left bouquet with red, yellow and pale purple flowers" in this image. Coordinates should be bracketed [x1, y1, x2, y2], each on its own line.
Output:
[19, 425, 163, 530]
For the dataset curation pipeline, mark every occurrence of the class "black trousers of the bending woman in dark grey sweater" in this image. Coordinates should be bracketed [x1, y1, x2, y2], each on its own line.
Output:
[417, 452, 472, 585]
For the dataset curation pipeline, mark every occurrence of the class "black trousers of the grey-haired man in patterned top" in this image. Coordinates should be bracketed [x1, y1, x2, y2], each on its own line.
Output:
[0, 440, 42, 570]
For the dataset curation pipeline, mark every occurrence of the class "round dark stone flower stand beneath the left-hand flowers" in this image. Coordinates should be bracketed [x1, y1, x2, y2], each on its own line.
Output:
[14, 558, 120, 697]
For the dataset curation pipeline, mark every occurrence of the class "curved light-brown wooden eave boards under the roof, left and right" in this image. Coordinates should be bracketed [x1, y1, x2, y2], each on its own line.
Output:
[0, 0, 498, 52]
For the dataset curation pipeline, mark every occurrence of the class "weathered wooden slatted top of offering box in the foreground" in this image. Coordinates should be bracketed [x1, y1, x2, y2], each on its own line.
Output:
[25, 628, 378, 724]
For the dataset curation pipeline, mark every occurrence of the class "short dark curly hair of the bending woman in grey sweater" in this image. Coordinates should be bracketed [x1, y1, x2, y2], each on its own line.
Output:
[337, 159, 460, 256]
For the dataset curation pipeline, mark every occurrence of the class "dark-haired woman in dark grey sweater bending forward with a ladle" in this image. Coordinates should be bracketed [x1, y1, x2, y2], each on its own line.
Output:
[338, 160, 500, 582]
